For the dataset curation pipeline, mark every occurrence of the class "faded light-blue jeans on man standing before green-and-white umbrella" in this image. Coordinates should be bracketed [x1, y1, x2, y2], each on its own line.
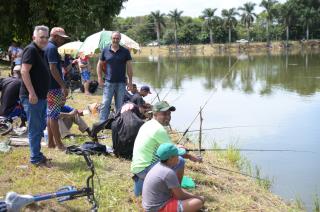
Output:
[100, 81, 126, 122]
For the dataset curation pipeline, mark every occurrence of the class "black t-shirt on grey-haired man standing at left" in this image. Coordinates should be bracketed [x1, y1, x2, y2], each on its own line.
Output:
[20, 42, 50, 99]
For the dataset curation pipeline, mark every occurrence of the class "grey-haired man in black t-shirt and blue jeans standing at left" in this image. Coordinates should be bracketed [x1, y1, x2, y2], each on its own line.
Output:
[20, 26, 50, 167]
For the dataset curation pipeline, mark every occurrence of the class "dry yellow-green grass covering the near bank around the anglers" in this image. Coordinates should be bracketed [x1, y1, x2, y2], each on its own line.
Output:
[0, 62, 305, 212]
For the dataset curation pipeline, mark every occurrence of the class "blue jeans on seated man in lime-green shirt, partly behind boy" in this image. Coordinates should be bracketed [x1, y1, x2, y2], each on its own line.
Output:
[134, 156, 185, 197]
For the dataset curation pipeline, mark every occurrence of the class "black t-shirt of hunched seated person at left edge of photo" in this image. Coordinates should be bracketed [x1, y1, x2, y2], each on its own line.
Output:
[0, 77, 21, 116]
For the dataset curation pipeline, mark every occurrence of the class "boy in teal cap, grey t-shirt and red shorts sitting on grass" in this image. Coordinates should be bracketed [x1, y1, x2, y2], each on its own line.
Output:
[142, 143, 204, 212]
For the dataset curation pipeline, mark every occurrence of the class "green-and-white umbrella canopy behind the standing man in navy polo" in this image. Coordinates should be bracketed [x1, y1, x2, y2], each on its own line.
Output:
[79, 30, 140, 55]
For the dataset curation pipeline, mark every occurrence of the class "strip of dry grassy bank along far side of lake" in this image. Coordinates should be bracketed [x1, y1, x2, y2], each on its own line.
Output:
[132, 40, 320, 57]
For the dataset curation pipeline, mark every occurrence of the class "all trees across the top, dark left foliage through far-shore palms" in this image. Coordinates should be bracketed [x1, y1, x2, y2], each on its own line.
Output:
[0, 0, 320, 47]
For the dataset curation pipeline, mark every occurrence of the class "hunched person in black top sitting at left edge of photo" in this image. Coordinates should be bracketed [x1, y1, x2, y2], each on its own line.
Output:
[0, 65, 27, 127]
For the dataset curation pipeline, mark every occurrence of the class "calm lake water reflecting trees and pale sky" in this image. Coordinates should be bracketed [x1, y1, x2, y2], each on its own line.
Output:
[133, 53, 320, 210]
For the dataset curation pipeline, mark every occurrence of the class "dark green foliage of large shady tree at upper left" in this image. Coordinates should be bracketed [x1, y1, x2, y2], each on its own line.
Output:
[0, 0, 127, 47]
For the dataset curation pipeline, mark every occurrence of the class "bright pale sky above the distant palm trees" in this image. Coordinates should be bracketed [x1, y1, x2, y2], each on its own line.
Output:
[119, 0, 286, 17]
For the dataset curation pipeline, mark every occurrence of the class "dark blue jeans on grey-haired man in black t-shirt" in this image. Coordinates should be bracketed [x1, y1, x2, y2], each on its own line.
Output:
[21, 97, 47, 163]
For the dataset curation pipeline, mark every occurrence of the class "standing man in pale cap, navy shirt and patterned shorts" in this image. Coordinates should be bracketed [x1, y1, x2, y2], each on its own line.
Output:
[45, 27, 69, 150]
